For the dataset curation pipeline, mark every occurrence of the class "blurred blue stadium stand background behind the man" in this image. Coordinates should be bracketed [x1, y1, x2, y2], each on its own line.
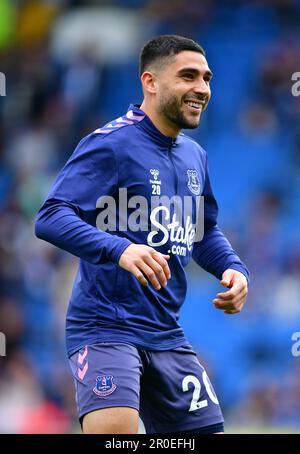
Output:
[0, 0, 300, 433]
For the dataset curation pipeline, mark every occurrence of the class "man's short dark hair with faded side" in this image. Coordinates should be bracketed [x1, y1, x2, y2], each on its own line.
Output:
[140, 35, 205, 75]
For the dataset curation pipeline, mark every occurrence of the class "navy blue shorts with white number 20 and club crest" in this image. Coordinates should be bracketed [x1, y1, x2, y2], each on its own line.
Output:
[70, 342, 224, 433]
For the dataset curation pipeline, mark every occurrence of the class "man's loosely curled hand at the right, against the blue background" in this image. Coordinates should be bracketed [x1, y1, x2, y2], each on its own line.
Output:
[213, 268, 248, 314]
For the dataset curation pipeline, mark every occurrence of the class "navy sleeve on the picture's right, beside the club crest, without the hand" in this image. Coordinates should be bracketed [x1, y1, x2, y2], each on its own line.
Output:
[193, 153, 249, 281]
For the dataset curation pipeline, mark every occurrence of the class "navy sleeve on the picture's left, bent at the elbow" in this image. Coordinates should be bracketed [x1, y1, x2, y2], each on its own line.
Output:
[35, 135, 131, 264]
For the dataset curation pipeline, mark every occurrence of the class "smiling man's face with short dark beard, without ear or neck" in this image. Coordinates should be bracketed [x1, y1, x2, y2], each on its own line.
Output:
[156, 51, 212, 129]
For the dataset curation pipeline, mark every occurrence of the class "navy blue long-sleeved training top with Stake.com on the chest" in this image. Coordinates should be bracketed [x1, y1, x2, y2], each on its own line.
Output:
[35, 105, 249, 356]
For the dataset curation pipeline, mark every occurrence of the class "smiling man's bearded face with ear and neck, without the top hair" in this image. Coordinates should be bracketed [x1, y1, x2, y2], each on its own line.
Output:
[140, 46, 212, 138]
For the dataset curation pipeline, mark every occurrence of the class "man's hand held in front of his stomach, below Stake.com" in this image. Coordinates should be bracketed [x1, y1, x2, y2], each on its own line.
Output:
[119, 244, 171, 290]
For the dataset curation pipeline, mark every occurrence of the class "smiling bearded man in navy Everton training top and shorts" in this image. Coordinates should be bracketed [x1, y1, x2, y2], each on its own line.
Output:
[36, 35, 248, 434]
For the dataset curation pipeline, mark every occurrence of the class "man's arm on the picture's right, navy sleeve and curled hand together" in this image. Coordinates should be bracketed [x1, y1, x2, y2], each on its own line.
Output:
[193, 154, 249, 314]
